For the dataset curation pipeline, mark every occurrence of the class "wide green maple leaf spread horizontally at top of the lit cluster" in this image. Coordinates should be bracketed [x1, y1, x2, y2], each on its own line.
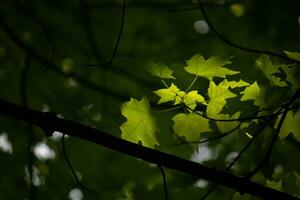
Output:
[184, 54, 239, 80]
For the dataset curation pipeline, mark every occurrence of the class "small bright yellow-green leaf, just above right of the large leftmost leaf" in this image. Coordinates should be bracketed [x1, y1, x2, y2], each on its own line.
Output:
[154, 83, 184, 104]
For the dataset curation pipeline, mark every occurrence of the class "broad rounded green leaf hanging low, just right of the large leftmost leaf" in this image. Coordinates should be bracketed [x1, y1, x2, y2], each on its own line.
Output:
[172, 113, 211, 142]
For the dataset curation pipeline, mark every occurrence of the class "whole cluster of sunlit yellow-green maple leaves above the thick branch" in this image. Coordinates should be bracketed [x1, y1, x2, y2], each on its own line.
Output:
[121, 52, 300, 147]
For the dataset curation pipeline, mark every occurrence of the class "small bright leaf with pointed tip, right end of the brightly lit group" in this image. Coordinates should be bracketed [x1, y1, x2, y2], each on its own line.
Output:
[241, 81, 266, 107]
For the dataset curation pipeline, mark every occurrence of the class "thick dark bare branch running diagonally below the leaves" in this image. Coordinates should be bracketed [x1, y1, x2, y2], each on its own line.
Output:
[0, 99, 299, 200]
